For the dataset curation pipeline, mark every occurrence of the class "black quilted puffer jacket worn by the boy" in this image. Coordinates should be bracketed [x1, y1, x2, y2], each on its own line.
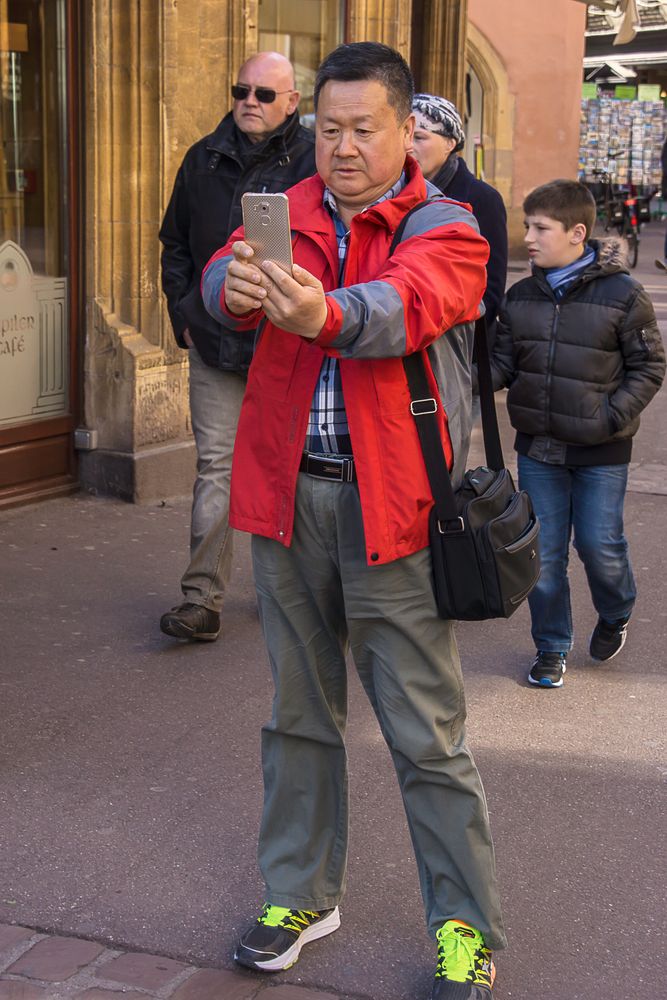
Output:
[492, 240, 665, 465]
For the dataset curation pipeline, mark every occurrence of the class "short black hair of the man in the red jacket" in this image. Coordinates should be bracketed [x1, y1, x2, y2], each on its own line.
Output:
[313, 42, 415, 122]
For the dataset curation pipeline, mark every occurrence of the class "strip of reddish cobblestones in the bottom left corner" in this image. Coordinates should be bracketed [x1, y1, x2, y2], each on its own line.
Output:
[0, 924, 347, 1000]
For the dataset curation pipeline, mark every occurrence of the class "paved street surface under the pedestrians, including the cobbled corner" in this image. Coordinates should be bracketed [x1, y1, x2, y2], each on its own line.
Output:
[0, 224, 667, 1000]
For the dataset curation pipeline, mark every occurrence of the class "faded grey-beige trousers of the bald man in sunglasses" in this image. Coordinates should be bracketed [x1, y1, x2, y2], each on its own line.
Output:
[181, 347, 246, 611]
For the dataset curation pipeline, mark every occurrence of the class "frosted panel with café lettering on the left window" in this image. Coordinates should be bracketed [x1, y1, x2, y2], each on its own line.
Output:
[0, 240, 68, 427]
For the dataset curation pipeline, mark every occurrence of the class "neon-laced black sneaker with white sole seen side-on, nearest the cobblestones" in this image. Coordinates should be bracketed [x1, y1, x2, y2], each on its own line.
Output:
[234, 903, 340, 972]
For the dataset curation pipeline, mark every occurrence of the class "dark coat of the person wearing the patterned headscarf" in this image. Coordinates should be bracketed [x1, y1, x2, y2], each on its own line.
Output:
[431, 156, 507, 332]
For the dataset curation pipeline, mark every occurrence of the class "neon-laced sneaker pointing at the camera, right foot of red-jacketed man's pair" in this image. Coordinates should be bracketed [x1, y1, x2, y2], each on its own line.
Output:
[431, 920, 496, 1000]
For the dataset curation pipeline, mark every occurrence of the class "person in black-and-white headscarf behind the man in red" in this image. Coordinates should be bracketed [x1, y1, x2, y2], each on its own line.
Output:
[412, 94, 507, 344]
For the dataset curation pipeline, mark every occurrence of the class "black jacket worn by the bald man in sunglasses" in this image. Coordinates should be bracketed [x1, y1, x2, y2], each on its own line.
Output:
[160, 112, 315, 371]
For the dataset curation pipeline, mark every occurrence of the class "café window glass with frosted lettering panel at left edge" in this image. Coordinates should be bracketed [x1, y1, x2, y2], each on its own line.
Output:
[0, 0, 69, 430]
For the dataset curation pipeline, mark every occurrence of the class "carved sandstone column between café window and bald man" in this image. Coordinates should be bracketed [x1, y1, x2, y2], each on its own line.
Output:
[80, 0, 257, 500]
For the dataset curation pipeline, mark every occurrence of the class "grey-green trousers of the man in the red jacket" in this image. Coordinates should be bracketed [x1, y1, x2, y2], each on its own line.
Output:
[252, 473, 506, 948]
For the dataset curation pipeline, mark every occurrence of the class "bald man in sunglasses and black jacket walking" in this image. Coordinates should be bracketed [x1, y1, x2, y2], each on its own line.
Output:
[160, 52, 315, 642]
